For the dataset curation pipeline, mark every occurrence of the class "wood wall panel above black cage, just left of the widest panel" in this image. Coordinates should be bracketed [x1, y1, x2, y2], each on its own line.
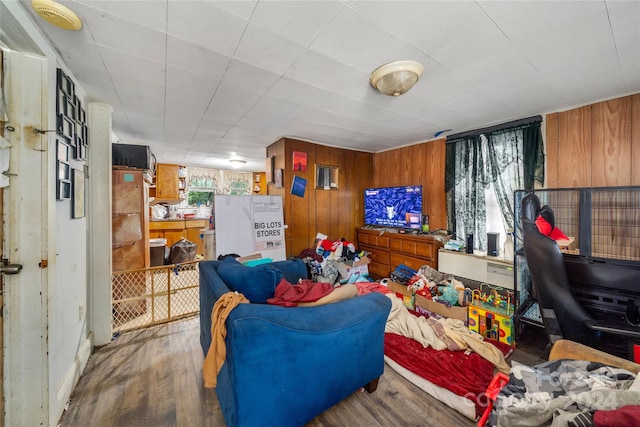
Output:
[558, 105, 592, 188]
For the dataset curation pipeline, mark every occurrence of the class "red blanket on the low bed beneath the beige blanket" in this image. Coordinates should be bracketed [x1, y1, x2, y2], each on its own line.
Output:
[384, 320, 512, 416]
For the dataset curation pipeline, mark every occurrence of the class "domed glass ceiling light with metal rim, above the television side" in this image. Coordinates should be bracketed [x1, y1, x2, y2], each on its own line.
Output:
[369, 61, 424, 96]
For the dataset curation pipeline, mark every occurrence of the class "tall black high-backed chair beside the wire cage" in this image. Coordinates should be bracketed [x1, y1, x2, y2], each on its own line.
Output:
[521, 194, 640, 357]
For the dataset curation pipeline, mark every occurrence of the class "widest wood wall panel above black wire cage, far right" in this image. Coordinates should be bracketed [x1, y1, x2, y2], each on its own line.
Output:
[591, 96, 631, 187]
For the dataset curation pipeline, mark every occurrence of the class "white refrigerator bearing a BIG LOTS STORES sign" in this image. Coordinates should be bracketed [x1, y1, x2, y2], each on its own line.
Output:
[213, 195, 287, 261]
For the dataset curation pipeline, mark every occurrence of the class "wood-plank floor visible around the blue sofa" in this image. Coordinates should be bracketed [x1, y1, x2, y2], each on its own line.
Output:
[59, 317, 544, 427]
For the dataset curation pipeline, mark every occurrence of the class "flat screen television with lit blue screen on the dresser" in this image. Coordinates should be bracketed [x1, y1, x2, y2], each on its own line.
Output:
[364, 185, 422, 229]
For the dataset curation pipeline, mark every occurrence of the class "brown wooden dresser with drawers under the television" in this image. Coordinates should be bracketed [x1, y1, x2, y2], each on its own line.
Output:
[357, 228, 443, 278]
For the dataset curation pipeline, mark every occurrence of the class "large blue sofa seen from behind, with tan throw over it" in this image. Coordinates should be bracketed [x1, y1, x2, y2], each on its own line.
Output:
[200, 260, 391, 427]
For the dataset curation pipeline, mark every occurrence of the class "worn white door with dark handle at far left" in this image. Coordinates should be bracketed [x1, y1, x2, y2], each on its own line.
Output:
[2, 50, 50, 426]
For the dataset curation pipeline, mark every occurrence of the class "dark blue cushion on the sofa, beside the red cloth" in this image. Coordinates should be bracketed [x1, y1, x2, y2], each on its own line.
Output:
[218, 258, 282, 304]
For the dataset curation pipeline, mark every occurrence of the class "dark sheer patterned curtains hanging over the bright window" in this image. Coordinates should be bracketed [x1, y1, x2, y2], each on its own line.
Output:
[445, 122, 544, 250]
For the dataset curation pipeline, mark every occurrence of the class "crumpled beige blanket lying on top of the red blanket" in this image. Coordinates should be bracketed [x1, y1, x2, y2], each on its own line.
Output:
[385, 293, 509, 374]
